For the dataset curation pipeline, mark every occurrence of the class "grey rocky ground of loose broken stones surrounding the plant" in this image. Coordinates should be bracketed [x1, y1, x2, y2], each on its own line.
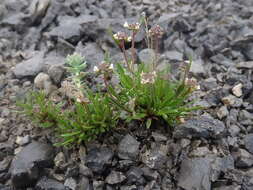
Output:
[0, 0, 253, 190]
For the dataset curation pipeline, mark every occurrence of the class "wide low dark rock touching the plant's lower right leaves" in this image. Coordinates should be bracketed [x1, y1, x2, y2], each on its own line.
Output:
[173, 116, 226, 139]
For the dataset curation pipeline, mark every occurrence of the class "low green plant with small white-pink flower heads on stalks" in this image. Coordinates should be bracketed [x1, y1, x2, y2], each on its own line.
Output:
[18, 16, 199, 145]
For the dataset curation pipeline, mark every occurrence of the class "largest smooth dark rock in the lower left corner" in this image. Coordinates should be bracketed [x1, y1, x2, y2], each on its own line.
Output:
[10, 141, 54, 188]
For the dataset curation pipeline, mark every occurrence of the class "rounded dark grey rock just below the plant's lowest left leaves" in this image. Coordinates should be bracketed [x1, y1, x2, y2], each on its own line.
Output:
[86, 147, 113, 174]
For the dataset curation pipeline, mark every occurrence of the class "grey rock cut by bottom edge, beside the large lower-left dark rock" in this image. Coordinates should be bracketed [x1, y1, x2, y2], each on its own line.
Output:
[35, 177, 67, 190]
